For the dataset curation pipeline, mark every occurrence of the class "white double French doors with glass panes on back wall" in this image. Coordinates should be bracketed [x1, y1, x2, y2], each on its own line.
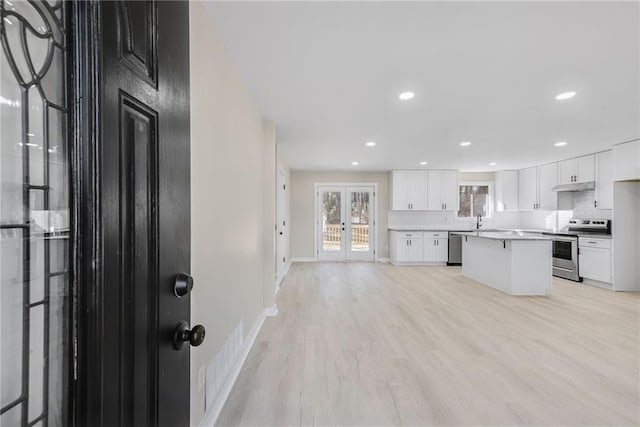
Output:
[316, 186, 375, 261]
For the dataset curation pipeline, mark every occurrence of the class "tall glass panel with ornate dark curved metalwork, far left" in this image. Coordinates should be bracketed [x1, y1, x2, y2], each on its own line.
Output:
[0, 0, 70, 427]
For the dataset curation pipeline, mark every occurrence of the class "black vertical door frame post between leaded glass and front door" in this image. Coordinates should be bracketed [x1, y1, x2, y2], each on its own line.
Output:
[68, 2, 102, 425]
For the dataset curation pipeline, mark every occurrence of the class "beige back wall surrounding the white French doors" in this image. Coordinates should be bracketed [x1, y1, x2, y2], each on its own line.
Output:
[290, 171, 389, 259]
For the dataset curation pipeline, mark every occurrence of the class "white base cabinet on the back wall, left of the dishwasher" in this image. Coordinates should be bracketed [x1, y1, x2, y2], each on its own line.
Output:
[391, 231, 449, 264]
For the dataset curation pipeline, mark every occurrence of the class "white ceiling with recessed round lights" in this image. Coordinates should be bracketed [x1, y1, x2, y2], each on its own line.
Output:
[207, 1, 640, 171]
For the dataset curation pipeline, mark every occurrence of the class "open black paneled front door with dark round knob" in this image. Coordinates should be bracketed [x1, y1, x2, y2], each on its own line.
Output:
[77, 1, 190, 427]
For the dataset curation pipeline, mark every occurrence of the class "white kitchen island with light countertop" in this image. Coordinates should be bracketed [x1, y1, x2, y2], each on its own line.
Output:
[453, 231, 552, 295]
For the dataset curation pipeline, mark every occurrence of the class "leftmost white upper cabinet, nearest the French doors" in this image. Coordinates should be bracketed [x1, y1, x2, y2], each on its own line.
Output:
[391, 170, 427, 211]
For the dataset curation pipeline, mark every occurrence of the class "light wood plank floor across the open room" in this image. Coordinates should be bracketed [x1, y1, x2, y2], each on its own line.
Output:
[218, 263, 640, 426]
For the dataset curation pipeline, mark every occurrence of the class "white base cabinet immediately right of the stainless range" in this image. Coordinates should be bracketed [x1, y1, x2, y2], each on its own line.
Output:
[578, 237, 611, 283]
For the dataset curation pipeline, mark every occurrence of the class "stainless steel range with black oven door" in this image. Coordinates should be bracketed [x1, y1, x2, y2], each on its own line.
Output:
[544, 218, 611, 282]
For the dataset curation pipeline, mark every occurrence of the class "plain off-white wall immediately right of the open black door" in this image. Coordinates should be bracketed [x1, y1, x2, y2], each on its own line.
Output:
[189, 2, 275, 425]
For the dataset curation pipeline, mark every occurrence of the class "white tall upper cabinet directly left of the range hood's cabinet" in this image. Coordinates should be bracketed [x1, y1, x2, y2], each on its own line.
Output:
[518, 163, 558, 210]
